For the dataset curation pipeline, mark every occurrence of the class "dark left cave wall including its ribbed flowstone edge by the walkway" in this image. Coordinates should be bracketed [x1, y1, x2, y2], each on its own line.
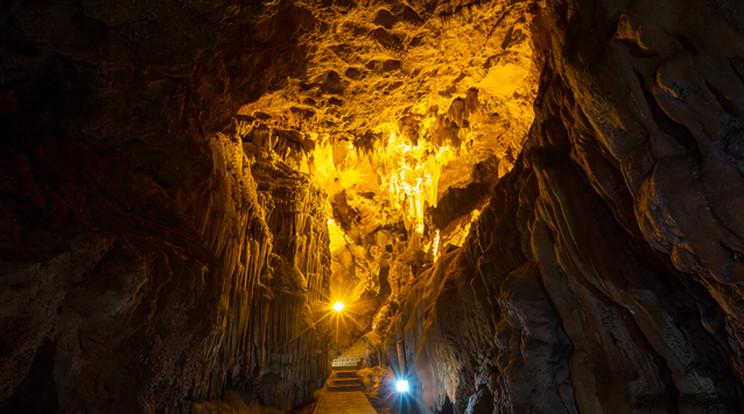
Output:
[0, 1, 329, 412]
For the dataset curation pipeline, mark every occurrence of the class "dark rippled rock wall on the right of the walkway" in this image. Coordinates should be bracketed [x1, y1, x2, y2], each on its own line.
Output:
[385, 0, 744, 413]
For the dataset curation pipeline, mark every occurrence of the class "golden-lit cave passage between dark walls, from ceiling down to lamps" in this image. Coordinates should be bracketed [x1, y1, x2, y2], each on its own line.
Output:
[225, 2, 540, 409]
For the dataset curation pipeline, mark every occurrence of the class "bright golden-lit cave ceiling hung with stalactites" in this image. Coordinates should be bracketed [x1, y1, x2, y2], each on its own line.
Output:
[241, 0, 540, 300]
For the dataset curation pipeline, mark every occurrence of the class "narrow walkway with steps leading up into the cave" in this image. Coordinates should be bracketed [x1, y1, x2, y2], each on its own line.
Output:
[314, 341, 377, 414]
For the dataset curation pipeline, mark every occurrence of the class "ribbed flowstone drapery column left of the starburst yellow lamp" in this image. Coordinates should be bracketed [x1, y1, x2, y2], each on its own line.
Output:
[183, 136, 330, 408]
